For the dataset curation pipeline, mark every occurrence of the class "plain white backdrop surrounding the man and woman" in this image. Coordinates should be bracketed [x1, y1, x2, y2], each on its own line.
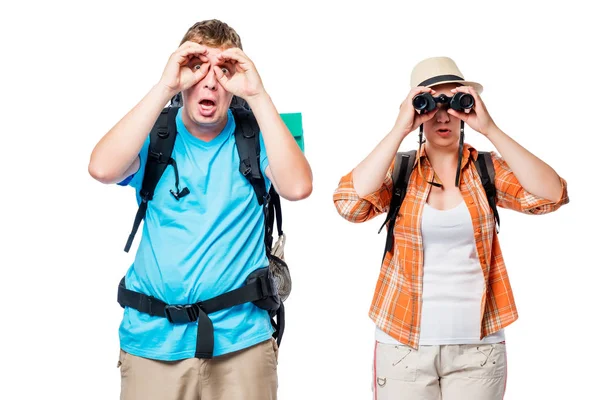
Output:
[0, 0, 600, 400]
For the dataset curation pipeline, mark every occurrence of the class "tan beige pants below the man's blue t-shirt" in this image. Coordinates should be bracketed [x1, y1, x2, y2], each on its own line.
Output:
[118, 339, 278, 400]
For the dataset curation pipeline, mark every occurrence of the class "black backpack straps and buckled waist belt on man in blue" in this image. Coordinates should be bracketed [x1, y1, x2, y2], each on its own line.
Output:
[117, 94, 291, 358]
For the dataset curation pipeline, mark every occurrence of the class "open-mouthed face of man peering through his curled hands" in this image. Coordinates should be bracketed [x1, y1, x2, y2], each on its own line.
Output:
[183, 47, 235, 133]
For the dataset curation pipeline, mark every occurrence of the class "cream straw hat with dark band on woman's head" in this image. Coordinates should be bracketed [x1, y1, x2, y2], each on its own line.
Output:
[410, 57, 483, 93]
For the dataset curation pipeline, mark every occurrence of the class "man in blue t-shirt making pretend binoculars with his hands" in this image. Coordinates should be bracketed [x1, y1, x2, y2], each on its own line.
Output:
[89, 20, 312, 400]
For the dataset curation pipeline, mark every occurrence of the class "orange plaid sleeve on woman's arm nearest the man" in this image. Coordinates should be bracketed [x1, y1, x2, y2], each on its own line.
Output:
[333, 162, 394, 222]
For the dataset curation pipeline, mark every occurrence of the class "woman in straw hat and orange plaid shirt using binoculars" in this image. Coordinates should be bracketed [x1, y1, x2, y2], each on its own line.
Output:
[333, 57, 569, 400]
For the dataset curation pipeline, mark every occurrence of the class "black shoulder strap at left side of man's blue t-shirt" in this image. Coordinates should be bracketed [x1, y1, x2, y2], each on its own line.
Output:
[125, 107, 178, 252]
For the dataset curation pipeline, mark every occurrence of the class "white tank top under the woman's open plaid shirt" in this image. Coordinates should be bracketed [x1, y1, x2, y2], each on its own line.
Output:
[375, 201, 504, 345]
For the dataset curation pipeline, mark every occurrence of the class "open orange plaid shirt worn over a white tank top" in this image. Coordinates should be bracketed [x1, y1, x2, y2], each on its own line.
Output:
[333, 144, 569, 349]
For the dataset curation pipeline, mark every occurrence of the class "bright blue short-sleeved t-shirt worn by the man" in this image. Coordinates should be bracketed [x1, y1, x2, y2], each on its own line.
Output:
[119, 109, 273, 360]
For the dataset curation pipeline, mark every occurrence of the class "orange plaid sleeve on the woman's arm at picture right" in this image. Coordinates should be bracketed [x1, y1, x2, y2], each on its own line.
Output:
[491, 151, 569, 215]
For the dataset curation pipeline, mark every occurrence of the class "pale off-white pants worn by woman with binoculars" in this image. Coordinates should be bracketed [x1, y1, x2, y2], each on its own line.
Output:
[373, 342, 506, 400]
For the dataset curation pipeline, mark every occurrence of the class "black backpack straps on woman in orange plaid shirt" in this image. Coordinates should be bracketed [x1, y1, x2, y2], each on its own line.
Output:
[379, 150, 500, 259]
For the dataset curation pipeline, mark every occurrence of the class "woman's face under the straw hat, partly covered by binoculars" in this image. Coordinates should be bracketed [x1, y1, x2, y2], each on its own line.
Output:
[423, 83, 460, 147]
